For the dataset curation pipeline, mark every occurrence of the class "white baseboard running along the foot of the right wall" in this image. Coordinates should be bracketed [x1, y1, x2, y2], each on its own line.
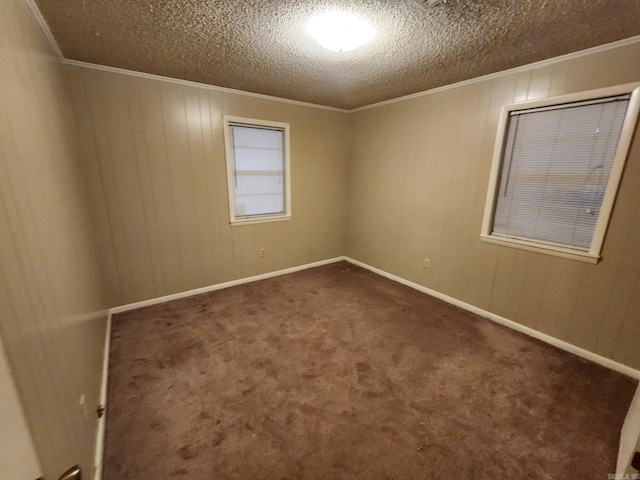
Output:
[344, 257, 640, 380]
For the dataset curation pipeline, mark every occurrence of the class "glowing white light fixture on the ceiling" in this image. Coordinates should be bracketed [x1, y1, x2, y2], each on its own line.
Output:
[307, 12, 376, 52]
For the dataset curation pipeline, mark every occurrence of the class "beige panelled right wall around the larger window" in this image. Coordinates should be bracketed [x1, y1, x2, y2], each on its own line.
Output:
[347, 43, 640, 368]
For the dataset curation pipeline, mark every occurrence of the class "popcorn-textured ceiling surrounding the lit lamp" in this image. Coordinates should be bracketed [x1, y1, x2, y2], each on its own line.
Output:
[36, 0, 640, 109]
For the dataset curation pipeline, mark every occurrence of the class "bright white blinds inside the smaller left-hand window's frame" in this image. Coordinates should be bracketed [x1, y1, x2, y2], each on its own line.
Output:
[229, 122, 286, 218]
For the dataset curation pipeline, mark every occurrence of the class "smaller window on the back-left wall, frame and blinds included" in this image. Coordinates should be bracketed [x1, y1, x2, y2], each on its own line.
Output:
[224, 115, 291, 224]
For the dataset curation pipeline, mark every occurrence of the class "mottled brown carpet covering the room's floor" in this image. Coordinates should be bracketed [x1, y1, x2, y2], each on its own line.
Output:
[104, 262, 636, 480]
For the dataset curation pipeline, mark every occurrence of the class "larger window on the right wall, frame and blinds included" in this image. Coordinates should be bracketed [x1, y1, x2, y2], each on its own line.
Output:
[481, 85, 640, 263]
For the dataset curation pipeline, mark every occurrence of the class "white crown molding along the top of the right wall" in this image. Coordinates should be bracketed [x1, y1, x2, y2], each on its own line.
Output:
[349, 35, 640, 113]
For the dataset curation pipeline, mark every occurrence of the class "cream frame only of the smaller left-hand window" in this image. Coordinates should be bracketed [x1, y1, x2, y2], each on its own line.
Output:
[222, 115, 291, 226]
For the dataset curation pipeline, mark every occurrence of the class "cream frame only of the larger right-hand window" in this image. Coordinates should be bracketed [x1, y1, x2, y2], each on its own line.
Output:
[480, 83, 640, 264]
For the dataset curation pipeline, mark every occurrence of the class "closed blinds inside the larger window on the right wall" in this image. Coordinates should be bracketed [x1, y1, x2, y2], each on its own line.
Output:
[491, 95, 629, 251]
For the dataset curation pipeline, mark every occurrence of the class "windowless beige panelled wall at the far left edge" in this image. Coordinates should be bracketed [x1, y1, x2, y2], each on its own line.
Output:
[0, 0, 106, 478]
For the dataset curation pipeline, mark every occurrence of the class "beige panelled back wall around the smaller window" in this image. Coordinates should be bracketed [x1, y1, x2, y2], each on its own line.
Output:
[67, 66, 348, 306]
